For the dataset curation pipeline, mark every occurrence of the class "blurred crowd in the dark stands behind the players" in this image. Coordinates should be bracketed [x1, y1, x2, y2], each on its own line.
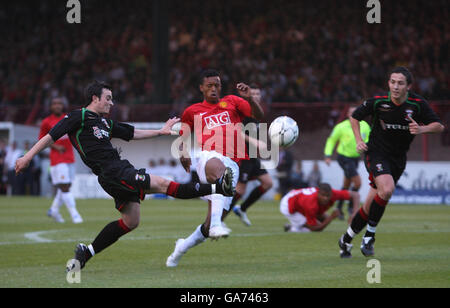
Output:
[0, 0, 450, 124]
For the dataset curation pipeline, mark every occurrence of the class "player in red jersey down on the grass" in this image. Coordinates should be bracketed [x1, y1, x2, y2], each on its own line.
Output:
[280, 183, 359, 232]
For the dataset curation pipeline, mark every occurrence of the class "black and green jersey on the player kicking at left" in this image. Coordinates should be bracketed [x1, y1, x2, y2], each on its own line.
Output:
[49, 108, 134, 175]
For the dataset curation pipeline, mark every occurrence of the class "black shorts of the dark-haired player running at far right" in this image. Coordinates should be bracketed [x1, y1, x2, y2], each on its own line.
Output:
[364, 151, 406, 188]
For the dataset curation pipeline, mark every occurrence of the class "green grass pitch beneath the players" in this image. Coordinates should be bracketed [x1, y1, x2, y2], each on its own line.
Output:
[0, 197, 450, 288]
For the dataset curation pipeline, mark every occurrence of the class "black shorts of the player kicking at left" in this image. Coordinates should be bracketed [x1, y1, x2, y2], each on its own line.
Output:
[98, 161, 150, 211]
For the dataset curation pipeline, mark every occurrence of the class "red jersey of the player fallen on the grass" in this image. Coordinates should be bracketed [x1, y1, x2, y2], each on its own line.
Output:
[288, 187, 351, 226]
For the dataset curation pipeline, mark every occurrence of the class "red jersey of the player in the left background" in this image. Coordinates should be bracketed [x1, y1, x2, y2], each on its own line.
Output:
[39, 114, 75, 166]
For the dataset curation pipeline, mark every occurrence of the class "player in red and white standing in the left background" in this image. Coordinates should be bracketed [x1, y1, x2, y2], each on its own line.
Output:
[39, 97, 83, 224]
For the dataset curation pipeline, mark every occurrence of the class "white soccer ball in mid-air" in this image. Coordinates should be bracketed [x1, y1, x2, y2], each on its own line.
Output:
[269, 116, 298, 148]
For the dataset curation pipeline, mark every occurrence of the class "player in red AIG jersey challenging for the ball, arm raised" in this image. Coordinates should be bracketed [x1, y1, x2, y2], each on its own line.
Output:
[166, 69, 264, 267]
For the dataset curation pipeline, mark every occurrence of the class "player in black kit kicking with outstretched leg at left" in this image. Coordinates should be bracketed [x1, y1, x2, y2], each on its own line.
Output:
[16, 81, 234, 271]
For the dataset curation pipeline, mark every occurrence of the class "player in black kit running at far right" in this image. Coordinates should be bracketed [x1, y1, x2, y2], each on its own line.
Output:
[339, 67, 444, 258]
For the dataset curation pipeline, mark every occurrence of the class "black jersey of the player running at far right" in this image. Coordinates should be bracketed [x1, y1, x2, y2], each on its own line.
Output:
[352, 92, 440, 155]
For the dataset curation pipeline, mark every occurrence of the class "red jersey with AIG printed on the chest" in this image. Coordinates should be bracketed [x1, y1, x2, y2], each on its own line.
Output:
[181, 95, 252, 162]
